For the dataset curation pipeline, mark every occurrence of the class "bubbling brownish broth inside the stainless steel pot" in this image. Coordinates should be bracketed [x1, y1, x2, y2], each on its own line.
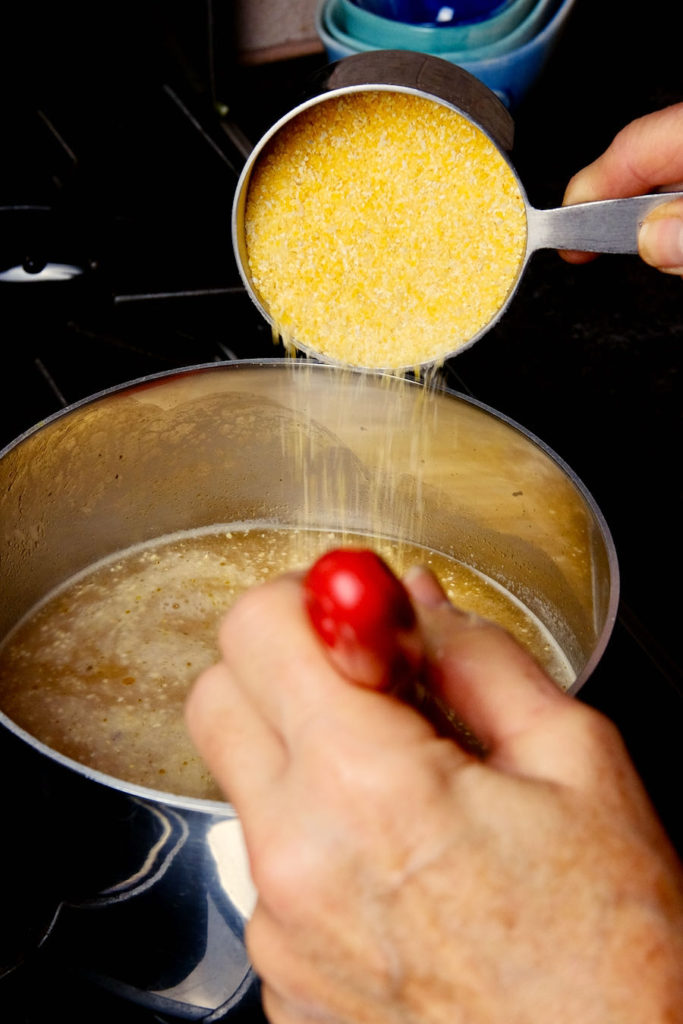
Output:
[0, 523, 573, 799]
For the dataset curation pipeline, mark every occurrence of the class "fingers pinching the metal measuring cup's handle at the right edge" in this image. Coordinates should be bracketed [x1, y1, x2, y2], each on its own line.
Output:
[561, 103, 683, 275]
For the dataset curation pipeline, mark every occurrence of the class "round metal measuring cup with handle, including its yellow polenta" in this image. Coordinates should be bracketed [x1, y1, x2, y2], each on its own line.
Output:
[232, 50, 671, 371]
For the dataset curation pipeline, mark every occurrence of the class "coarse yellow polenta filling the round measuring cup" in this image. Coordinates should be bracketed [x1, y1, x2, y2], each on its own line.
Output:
[245, 90, 526, 369]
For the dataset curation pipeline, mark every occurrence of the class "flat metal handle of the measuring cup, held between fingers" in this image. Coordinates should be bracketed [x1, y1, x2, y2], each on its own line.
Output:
[527, 191, 683, 253]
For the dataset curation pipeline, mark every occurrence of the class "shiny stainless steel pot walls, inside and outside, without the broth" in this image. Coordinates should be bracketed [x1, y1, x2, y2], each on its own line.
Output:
[0, 360, 618, 1007]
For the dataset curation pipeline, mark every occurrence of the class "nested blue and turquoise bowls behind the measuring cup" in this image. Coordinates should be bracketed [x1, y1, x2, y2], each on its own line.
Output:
[316, 0, 575, 108]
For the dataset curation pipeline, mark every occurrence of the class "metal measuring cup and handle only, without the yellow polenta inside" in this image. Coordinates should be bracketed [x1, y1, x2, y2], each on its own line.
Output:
[232, 50, 681, 372]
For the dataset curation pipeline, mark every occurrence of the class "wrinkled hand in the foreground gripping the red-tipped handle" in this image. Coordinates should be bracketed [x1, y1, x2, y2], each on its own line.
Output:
[187, 571, 683, 1024]
